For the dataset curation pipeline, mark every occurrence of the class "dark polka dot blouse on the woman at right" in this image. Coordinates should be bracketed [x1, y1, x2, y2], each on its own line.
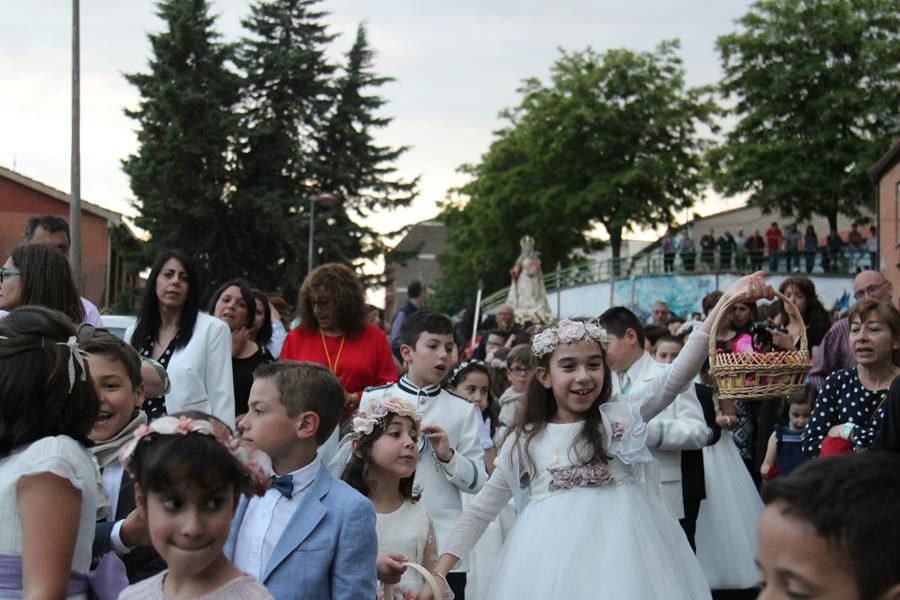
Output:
[803, 368, 888, 456]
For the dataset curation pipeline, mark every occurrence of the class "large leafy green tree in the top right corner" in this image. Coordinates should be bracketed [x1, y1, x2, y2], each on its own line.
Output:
[712, 0, 900, 229]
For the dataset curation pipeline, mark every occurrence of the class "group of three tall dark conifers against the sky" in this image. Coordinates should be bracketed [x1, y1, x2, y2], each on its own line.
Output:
[123, 0, 416, 291]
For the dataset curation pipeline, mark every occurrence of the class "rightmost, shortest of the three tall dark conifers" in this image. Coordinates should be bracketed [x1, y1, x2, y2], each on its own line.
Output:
[312, 24, 418, 272]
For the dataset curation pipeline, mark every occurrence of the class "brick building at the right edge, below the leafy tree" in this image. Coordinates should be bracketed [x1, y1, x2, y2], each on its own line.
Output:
[869, 139, 900, 300]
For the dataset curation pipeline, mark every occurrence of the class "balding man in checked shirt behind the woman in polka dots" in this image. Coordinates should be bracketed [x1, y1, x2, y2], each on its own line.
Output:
[809, 271, 894, 391]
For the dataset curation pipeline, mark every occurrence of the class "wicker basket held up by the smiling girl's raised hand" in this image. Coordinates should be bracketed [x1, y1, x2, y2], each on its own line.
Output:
[709, 292, 812, 400]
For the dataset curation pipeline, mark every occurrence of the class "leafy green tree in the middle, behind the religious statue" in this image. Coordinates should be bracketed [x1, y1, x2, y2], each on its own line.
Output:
[440, 41, 716, 310]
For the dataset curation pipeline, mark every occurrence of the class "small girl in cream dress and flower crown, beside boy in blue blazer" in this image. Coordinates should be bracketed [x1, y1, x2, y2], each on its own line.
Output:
[342, 396, 453, 600]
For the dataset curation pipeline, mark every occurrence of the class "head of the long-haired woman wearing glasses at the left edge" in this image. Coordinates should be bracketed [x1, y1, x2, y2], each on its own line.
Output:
[0, 244, 84, 325]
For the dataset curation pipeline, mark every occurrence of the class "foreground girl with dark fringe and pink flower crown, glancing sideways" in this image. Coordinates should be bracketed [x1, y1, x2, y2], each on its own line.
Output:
[119, 411, 272, 600]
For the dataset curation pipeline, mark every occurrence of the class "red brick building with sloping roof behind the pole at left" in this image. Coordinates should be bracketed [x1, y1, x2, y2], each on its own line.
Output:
[0, 167, 136, 308]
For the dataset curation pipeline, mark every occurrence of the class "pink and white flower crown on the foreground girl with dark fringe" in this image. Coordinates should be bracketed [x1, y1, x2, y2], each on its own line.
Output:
[119, 416, 271, 495]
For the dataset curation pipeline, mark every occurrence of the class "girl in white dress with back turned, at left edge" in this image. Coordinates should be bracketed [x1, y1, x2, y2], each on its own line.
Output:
[0, 306, 102, 598]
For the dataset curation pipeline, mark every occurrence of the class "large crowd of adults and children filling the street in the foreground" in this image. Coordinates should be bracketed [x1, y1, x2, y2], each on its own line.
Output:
[0, 217, 900, 600]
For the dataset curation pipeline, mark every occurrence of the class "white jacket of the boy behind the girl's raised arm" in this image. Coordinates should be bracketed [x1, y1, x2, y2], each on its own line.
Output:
[612, 352, 709, 519]
